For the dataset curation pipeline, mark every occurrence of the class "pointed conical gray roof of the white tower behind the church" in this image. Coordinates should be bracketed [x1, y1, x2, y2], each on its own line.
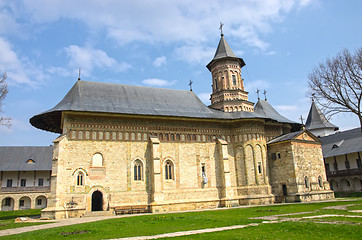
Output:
[305, 101, 339, 131]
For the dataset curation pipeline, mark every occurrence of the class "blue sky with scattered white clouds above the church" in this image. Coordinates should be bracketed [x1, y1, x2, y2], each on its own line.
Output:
[0, 0, 362, 146]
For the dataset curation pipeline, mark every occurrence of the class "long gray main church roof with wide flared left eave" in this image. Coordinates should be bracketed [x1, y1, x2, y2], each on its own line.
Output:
[30, 81, 294, 133]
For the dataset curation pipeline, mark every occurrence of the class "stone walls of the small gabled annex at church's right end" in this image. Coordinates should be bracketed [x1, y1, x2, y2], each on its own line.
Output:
[268, 133, 334, 202]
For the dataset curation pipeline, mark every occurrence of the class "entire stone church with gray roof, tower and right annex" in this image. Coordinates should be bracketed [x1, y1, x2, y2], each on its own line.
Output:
[30, 34, 333, 218]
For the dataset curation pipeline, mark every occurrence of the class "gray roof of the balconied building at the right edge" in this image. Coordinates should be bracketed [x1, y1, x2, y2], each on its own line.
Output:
[320, 128, 362, 158]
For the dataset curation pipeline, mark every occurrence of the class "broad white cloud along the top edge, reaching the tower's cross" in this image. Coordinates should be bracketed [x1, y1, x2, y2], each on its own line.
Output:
[14, 0, 311, 50]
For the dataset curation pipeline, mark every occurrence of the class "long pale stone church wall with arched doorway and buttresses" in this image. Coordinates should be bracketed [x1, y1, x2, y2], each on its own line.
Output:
[43, 112, 284, 218]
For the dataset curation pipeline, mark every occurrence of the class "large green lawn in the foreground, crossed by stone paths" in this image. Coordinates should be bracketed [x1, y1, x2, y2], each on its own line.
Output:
[0, 199, 362, 240]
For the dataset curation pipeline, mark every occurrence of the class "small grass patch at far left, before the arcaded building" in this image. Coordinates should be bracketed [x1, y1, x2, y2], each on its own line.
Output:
[0, 209, 48, 230]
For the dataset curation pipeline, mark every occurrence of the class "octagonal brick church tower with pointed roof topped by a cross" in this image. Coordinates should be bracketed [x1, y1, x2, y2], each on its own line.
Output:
[206, 28, 254, 112]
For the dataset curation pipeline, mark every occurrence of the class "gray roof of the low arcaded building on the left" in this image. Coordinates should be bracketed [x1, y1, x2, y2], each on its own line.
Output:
[0, 146, 53, 171]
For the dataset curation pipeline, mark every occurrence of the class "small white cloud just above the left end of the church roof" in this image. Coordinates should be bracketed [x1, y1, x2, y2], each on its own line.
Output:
[65, 45, 131, 76]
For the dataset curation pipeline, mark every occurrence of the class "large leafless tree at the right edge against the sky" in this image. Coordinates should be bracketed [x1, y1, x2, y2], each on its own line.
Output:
[308, 48, 362, 131]
